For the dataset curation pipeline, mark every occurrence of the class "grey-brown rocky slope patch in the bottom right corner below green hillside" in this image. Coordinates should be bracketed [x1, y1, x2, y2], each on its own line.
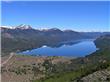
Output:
[81, 67, 110, 82]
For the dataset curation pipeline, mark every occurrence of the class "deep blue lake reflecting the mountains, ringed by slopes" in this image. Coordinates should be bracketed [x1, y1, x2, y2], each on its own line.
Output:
[19, 39, 97, 57]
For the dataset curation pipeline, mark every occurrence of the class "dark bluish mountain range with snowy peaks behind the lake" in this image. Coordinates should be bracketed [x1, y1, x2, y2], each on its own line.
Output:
[1, 24, 109, 54]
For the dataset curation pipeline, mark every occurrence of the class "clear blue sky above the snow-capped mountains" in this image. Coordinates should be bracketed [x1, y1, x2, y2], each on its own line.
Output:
[1, 1, 110, 31]
